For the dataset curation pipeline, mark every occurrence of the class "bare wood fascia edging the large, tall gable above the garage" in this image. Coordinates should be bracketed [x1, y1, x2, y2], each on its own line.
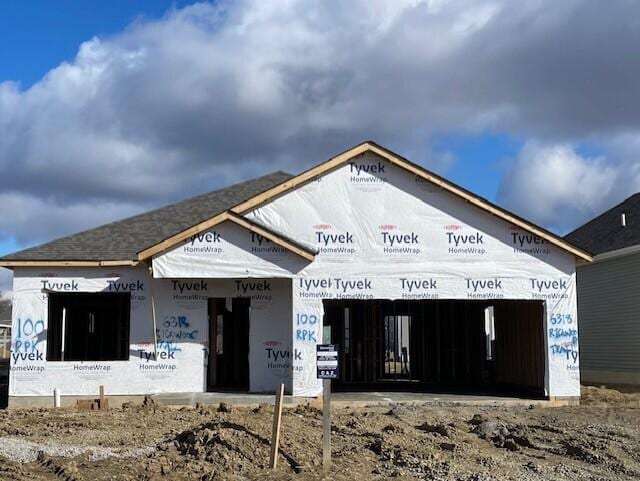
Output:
[232, 142, 592, 262]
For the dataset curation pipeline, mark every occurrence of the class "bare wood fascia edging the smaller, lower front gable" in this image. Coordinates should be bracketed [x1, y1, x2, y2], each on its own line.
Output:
[138, 212, 315, 262]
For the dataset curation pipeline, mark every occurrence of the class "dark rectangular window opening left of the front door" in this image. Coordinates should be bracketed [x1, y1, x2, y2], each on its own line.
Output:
[47, 293, 131, 361]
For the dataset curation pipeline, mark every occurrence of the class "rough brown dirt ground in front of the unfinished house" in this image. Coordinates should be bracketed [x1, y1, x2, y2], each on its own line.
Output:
[0, 387, 640, 481]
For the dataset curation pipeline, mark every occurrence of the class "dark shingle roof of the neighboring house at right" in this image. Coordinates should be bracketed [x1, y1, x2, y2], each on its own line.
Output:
[565, 193, 640, 255]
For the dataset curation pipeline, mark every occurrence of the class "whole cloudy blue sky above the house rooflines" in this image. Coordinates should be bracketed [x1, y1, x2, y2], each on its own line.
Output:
[0, 0, 640, 290]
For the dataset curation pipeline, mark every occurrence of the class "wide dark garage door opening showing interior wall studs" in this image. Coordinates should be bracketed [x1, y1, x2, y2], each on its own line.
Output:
[323, 300, 545, 396]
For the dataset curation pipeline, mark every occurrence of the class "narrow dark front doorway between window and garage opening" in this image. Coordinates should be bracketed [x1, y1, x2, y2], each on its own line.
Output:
[207, 297, 251, 391]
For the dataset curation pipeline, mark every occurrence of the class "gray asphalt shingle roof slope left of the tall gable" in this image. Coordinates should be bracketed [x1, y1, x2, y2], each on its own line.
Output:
[0, 171, 292, 261]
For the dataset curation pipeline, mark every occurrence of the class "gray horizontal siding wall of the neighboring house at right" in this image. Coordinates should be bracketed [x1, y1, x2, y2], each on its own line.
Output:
[576, 249, 640, 381]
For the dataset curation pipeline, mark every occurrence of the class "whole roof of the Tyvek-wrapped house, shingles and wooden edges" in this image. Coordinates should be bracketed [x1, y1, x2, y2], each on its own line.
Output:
[0, 142, 591, 267]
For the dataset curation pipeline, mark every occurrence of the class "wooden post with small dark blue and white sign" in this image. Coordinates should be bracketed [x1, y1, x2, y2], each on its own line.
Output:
[316, 344, 338, 471]
